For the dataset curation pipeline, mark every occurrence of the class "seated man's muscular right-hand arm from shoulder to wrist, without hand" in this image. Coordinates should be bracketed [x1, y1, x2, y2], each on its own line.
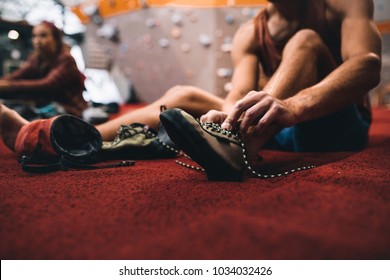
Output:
[285, 0, 381, 122]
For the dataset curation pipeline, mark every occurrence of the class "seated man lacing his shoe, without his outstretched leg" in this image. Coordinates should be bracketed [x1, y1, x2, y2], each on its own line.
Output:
[160, 0, 381, 180]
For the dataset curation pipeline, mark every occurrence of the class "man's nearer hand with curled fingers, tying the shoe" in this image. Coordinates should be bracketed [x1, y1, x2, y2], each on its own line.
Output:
[221, 91, 296, 134]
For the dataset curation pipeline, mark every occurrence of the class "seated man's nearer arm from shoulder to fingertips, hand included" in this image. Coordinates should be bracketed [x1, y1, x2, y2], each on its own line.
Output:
[222, 0, 381, 133]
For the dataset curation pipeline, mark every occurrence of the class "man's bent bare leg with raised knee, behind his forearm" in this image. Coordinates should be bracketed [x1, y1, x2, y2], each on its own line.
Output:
[245, 30, 336, 159]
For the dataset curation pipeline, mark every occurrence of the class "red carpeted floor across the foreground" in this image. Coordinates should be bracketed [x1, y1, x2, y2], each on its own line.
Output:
[0, 106, 390, 259]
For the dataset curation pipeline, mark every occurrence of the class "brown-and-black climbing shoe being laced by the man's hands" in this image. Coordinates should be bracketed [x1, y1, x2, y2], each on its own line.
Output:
[160, 109, 245, 181]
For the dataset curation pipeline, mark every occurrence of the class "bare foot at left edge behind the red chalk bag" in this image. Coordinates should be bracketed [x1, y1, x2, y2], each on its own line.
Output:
[0, 104, 29, 151]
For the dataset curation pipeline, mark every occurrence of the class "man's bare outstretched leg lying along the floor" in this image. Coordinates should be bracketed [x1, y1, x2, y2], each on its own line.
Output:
[96, 86, 223, 141]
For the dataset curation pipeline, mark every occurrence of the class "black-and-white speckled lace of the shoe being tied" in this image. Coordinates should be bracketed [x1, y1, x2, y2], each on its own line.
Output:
[176, 121, 315, 179]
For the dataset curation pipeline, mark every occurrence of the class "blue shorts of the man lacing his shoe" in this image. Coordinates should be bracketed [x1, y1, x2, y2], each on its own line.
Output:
[265, 105, 371, 152]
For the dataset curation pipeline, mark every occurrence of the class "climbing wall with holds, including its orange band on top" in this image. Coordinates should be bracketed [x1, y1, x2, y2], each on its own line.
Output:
[75, 0, 390, 102]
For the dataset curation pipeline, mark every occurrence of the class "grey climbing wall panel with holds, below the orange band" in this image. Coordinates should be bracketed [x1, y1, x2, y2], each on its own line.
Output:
[82, 6, 260, 102]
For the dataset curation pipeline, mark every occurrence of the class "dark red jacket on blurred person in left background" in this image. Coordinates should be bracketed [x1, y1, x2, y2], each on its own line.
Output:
[0, 51, 87, 117]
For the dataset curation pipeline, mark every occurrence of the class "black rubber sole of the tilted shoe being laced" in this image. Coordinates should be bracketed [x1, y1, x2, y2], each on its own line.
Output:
[160, 109, 244, 182]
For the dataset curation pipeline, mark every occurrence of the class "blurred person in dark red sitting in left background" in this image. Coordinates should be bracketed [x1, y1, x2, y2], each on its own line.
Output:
[0, 21, 87, 119]
